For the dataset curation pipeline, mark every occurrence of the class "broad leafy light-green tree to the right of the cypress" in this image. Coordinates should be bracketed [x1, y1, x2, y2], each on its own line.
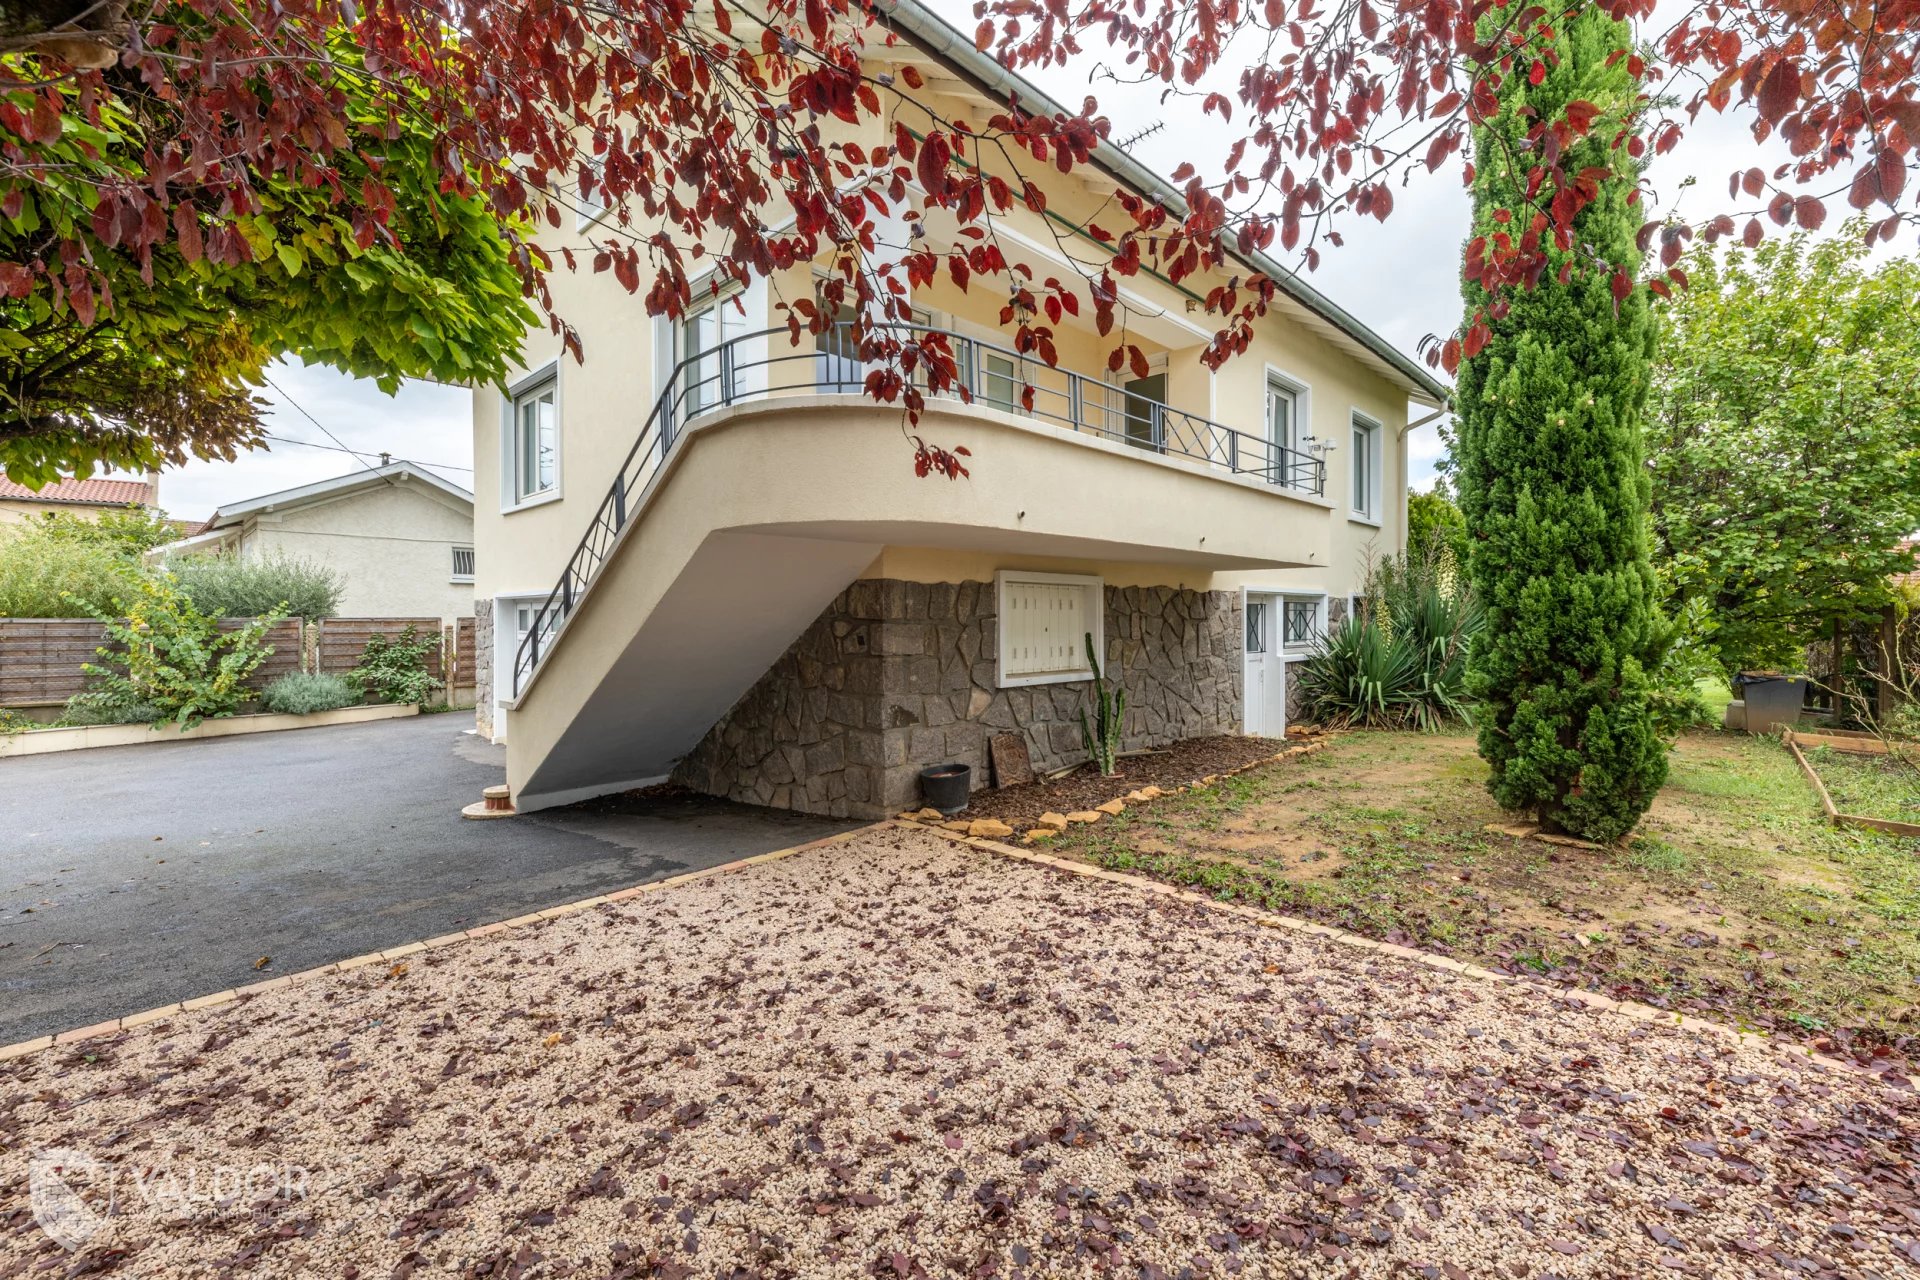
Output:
[1647, 223, 1920, 672]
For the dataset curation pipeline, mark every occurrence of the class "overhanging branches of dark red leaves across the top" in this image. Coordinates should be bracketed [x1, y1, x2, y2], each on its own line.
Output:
[0, 0, 1920, 474]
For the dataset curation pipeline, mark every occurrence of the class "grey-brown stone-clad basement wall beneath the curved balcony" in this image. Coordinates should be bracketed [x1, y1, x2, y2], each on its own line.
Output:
[674, 580, 1244, 818]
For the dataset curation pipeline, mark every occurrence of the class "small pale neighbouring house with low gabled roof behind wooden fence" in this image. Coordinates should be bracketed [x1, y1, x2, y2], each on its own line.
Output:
[148, 462, 474, 622]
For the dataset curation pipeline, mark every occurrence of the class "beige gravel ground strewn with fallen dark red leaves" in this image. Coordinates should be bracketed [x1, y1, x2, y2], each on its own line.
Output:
[0, 829, 1920, 1280]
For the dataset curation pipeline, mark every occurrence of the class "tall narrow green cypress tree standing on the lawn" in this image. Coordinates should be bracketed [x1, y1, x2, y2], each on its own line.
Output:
[1457, 6, 1667, 841]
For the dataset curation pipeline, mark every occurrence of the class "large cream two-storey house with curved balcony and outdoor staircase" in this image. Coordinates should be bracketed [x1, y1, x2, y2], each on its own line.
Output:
[474, 2, 1446, 816]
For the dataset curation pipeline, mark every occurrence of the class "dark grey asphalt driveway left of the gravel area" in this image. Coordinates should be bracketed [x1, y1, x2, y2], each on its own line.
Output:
[0, 714, 849, 1044]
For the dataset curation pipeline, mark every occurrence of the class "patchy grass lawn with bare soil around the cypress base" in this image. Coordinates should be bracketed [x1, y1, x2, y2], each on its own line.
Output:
[1054, 733, 1920, 1042]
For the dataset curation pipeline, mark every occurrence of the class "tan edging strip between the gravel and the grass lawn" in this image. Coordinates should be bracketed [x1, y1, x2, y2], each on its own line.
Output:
[895, 819, 1878, 1080]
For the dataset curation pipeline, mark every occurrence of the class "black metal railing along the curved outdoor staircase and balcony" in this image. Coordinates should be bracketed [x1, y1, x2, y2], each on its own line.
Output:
[513, 324, 1327, 697]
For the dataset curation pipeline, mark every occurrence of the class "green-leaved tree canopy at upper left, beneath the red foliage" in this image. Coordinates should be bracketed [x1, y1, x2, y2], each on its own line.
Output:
[0, 44, 534, 486]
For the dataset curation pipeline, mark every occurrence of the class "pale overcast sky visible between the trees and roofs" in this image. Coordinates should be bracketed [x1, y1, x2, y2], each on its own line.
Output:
[161, 0, 1866, 518]
